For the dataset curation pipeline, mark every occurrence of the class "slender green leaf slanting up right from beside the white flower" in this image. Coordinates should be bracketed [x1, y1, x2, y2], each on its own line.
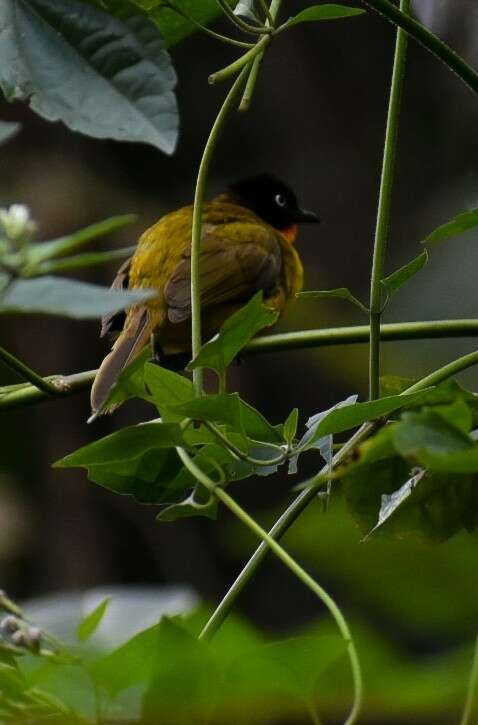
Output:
[26, 214, 136, 268]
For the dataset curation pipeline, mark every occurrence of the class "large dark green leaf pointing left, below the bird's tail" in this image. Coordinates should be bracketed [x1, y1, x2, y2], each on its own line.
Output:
[54, 422, 185, 504]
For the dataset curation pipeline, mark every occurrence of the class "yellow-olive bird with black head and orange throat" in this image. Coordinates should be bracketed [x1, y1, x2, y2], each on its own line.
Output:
[90, 174, 319, 420]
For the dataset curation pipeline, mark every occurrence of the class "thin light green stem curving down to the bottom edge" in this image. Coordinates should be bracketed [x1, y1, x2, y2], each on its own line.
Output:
[176, 448, 363, 725]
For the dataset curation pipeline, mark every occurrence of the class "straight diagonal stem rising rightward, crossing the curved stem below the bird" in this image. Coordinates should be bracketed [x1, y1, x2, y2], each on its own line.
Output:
[200, 352, 478, 640]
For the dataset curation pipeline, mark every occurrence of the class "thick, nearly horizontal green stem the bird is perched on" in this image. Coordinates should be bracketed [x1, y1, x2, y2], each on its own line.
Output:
[4, 320, 478, 409]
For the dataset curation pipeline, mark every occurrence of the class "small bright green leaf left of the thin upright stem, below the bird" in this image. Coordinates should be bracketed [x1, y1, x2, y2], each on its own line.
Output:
[144, 363, 194, 421]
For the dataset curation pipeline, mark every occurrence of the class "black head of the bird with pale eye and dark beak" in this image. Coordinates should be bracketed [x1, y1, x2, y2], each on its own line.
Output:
[229, 174, 320, 231]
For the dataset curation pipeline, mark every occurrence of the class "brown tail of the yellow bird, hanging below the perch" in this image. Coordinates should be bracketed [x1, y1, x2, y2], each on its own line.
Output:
[88, 307, 155, 423]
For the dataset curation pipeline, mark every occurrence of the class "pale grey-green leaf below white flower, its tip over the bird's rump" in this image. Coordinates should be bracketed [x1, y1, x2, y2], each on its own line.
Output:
[0, 276, 156, 319]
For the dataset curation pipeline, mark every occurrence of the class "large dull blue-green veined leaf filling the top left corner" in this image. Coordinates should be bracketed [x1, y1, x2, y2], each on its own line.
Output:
[0, 0, 178, 154]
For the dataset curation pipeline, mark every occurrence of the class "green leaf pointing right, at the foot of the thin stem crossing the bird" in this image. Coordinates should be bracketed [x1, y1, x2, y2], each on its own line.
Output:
[171, 393, 283, 443]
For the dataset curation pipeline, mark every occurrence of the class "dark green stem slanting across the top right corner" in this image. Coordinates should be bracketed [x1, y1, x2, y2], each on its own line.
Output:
[362, 0, 478, 93]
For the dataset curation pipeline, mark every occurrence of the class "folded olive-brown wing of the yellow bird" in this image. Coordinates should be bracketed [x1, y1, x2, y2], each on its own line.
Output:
[164, 224, 282, 323]
